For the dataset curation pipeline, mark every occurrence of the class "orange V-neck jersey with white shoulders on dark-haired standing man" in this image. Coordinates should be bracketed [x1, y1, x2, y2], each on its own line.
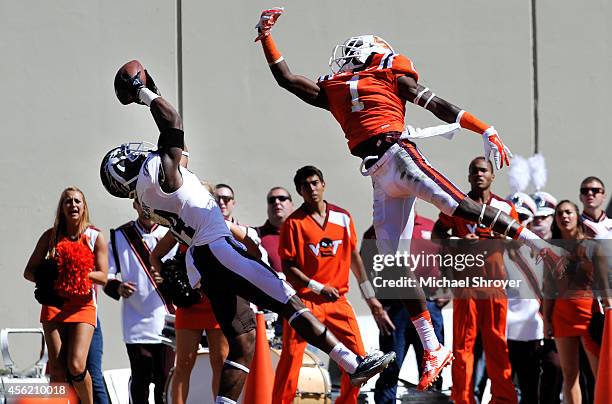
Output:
[278, 203, 357, 295]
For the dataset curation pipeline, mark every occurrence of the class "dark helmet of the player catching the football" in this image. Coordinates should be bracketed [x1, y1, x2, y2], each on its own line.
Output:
[100, 142, 157, 198]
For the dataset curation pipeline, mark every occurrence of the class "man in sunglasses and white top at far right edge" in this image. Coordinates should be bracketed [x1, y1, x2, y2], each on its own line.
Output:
[580, 177, 612, 238]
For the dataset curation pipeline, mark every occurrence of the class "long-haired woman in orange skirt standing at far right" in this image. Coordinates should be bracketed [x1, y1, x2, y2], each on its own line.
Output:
[544, 200, 599, 403]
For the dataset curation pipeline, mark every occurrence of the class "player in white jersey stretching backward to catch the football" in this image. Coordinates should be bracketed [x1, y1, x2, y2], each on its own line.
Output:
[100, 66, 395, 403]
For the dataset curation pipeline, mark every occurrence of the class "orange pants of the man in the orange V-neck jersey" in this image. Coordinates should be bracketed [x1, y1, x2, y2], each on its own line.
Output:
[272, 296, 365, 404]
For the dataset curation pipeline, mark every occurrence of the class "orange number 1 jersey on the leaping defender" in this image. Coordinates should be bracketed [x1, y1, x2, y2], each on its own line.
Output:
[318, 53, 419, 150]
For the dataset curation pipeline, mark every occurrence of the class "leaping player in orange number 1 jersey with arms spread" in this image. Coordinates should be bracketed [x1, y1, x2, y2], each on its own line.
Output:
[255, 8, 562, 389]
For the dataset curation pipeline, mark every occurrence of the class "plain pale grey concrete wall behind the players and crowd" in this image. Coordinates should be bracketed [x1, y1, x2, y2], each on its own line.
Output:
[0, 0, 612, 368]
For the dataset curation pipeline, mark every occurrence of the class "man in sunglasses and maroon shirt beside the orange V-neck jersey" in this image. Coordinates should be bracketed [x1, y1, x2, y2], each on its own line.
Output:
[257, 187, 293, 272]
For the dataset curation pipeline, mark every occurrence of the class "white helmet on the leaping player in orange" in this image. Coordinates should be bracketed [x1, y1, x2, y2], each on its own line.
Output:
[329, 35, 394, 74]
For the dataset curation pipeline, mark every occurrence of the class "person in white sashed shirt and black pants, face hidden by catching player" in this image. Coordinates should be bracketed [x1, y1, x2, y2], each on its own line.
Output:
[104, 200, 176, 404]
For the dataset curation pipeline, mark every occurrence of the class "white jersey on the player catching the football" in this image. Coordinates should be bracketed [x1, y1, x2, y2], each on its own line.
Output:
[136, 152, 231, 246]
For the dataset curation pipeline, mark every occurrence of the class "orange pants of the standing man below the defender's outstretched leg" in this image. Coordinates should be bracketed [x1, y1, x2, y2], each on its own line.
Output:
[451, 297, 518, 404]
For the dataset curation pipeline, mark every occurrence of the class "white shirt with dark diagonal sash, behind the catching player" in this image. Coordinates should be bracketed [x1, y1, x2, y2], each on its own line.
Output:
[108, 221, 178, 344]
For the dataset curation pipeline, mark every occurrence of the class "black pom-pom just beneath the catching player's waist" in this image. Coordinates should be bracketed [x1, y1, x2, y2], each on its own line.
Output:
[160, 255, 201, 307]
